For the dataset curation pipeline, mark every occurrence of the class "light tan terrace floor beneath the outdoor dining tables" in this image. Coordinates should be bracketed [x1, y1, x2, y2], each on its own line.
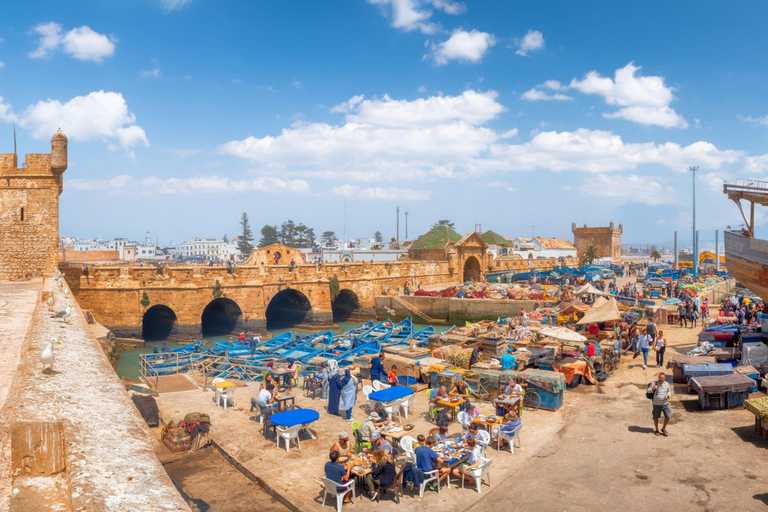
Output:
[157, 372, 563, 510]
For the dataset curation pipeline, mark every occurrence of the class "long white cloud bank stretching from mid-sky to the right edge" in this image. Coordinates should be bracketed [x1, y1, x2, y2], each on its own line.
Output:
[219, 89, 748, 182]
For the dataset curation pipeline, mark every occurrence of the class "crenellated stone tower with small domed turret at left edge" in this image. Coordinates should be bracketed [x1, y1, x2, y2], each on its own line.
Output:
[0, 131, 67, 281]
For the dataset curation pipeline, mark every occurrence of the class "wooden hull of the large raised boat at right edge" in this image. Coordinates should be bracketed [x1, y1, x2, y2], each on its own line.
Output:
[725, 231, 768, 299]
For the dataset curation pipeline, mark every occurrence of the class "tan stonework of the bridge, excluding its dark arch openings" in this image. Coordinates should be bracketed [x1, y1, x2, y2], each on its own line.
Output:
[61, 261, 461, 337]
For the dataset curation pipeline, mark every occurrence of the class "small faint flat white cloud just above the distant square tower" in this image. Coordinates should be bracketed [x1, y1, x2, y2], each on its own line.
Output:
[579, 174, 678, 206]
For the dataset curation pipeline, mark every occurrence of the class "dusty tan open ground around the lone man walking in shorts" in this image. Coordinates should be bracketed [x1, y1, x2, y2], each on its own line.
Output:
[472, 320, 768, 511]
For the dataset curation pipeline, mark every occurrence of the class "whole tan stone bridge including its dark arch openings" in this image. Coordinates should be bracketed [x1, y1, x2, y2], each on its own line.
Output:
[61, 261, 456, 339]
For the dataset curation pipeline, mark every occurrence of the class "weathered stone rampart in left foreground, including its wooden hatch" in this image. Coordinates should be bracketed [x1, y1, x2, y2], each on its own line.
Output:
[0, 280, 189, 512]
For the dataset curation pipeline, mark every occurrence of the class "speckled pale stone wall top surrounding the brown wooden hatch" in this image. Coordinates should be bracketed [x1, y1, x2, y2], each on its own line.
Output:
[0, 280, 189, 511]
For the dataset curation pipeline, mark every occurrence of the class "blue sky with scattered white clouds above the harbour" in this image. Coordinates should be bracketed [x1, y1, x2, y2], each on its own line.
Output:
[0, 0, 768, 243]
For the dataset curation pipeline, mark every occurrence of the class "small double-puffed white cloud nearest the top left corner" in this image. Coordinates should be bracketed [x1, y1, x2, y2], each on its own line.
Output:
[29, 22, 115, 63]
